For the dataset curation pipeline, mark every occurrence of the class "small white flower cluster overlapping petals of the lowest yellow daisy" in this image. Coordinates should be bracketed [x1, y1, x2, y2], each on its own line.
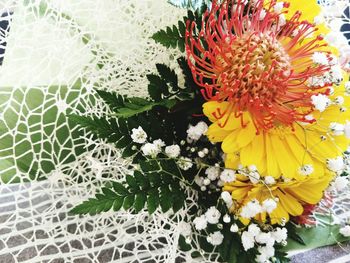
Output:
[240, 198, 277, 219]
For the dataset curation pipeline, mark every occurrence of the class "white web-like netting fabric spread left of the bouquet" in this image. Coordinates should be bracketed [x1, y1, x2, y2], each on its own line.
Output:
[0, 0, 348, 263]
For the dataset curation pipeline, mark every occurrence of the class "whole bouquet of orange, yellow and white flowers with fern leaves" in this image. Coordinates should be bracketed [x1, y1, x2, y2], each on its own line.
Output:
[65, 0, 350, 262]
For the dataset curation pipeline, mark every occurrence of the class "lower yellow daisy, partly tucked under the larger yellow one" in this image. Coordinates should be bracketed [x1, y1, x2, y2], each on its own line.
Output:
[223, 173, 332, 224]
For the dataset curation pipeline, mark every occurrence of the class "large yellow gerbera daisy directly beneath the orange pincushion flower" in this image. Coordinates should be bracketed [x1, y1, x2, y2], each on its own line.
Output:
[203, 95, 350, 180]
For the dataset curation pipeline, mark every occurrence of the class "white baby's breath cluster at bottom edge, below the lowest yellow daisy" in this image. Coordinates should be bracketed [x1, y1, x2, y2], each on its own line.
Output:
[242, 224, 288, 262]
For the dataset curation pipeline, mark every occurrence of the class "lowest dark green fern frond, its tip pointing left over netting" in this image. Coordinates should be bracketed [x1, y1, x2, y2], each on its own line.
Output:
[71, 161, 185, 215]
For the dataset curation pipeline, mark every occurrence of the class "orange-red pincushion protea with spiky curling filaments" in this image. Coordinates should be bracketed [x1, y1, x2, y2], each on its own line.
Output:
[186, 0, 332, 133]
